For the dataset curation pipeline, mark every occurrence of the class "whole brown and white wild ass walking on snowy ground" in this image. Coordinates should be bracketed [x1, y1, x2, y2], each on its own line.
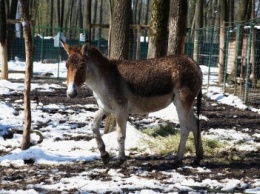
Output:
[61, 41, 203, 166]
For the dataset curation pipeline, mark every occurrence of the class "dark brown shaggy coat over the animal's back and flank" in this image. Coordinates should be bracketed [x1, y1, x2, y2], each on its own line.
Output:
[117, 55, 202, 97]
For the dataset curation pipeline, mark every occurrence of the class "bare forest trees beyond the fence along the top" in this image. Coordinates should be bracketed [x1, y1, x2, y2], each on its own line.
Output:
[4, 0, 260, 39]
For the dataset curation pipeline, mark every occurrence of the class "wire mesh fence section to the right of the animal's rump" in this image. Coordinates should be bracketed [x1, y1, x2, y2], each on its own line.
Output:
[186, 21, 260, 105]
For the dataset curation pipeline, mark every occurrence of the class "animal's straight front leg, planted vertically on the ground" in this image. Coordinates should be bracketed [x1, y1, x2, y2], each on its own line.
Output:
[116, 113, 127, 163]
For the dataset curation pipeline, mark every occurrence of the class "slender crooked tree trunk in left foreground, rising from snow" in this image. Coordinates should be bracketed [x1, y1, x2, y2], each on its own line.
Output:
[20, 0, 32, 150]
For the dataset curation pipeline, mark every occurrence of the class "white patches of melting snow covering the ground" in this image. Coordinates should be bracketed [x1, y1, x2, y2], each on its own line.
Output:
[0, 61, 260, 194]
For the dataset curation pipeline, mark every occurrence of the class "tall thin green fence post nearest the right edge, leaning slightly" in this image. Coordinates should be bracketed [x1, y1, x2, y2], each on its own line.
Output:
[244, 22, 254, 103]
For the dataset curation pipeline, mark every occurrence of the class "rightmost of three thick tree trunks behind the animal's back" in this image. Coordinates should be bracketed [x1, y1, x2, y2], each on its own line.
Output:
[167, 0, 188, 55]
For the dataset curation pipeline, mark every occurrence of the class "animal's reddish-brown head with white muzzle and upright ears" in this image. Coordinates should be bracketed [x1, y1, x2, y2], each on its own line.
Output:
[61, 40, 89, 98]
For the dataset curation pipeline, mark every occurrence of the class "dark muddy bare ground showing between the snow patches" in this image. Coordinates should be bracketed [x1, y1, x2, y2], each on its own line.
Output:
[0, 80, 260, 193]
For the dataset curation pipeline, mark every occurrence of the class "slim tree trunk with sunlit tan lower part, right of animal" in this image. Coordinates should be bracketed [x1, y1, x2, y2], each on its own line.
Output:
[218, 0, 227, 84]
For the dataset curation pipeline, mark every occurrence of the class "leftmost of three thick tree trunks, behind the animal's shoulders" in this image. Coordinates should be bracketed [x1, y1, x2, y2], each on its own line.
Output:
[110, 0, 131, 59]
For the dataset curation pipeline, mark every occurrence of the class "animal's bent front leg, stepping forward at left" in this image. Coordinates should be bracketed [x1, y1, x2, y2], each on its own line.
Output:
[91, 109, 109, 164]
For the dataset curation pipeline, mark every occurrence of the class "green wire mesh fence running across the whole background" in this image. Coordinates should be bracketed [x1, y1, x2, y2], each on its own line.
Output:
[3, 21, 260, 105]
